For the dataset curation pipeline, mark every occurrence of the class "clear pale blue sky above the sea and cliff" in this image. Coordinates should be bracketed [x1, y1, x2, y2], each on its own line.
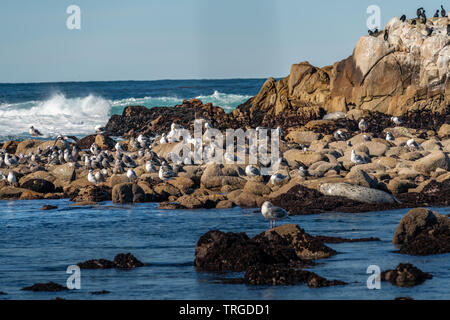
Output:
[0, 0, 444, 82]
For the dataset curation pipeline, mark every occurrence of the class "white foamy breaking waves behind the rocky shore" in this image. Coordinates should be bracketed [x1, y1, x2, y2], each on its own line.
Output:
[0, 91, 250, 141]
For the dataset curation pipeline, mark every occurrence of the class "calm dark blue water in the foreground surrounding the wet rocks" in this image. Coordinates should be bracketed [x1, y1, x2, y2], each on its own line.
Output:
[0, 200, 450, 299]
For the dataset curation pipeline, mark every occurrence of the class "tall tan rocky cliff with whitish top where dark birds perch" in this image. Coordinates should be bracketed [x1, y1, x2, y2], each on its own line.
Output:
[233, 17, 450, 118]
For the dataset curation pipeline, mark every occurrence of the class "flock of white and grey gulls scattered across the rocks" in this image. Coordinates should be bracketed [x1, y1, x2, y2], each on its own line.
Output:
[0, 117, 419, 227]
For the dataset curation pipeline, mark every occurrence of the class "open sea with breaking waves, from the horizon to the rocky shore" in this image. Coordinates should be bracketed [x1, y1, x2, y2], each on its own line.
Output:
[0, 79, 265, 141]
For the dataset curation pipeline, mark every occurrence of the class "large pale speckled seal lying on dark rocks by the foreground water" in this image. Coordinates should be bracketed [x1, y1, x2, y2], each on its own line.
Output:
[319, 182, 399, 204]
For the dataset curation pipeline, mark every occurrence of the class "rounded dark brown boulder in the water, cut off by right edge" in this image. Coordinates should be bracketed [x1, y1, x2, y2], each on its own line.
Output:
[392, 208, 450, 255]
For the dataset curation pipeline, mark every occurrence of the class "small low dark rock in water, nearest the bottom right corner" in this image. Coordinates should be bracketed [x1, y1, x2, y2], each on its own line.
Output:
[381, 263, 433, 287]
